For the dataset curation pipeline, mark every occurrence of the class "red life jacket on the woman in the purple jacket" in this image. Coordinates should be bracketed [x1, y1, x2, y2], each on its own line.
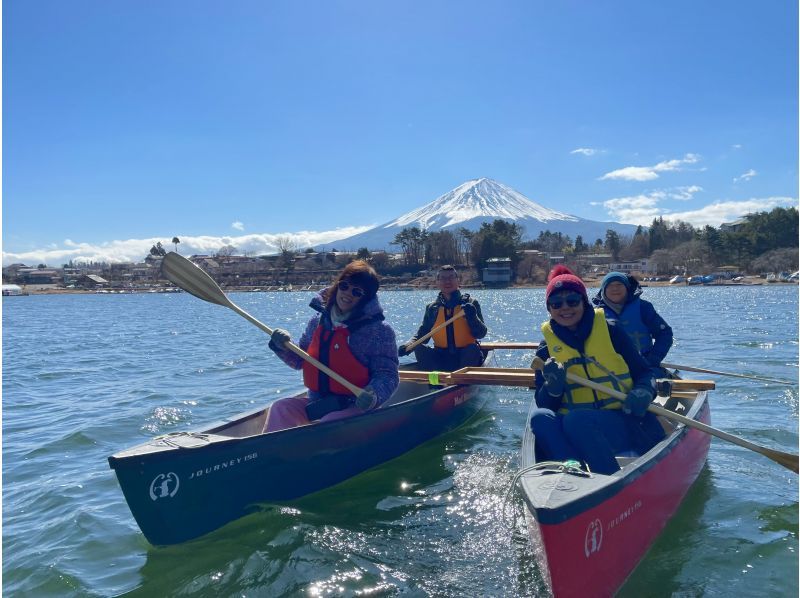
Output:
[303, 326, 369, 396]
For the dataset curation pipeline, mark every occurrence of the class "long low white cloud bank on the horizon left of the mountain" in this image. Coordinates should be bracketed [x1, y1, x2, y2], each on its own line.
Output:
[3, 224, 375, 266]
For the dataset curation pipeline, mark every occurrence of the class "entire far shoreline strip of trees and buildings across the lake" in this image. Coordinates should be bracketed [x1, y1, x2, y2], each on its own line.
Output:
[3, 208, 798, 293]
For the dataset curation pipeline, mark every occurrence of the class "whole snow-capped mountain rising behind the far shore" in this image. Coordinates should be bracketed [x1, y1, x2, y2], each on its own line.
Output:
[318, 178, 637, 250]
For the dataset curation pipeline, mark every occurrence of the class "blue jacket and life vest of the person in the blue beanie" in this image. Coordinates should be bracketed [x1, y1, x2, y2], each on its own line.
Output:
[592, 277, 672, 367]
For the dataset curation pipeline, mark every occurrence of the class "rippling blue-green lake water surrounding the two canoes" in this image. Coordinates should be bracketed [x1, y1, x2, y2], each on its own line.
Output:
[2, 286, 798, 597]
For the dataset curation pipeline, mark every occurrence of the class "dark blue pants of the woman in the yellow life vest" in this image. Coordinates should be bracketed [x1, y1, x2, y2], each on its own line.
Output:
[531, 409, 665, 474]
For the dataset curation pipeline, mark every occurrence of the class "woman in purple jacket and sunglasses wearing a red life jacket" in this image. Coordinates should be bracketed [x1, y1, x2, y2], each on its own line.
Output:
[264, 260, 399, 432]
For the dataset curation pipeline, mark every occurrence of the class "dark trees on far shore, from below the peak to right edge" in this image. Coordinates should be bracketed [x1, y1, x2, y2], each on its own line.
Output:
[392, 208, 799, 282]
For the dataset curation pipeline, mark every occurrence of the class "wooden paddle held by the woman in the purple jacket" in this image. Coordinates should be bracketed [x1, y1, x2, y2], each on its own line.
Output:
[161, 251, 363, 396]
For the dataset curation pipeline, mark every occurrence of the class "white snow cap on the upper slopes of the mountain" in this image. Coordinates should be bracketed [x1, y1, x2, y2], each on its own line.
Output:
[384, 178, 578, 230]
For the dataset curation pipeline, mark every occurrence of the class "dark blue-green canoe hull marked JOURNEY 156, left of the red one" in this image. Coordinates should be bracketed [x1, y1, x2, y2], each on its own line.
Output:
[109, 385, 481, 545]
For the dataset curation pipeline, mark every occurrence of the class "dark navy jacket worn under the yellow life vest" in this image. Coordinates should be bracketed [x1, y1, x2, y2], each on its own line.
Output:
[534, 306, 657, 412]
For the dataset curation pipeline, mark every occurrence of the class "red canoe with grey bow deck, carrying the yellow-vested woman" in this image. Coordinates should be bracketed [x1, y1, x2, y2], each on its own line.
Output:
[518, 392, 711, 598]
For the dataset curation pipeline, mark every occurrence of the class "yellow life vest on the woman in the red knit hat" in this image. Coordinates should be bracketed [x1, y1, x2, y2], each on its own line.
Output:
[542, 309, 632, 413]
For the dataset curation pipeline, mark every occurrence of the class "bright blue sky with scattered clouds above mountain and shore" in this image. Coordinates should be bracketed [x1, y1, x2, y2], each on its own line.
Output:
[3, 0, 798, 265]
